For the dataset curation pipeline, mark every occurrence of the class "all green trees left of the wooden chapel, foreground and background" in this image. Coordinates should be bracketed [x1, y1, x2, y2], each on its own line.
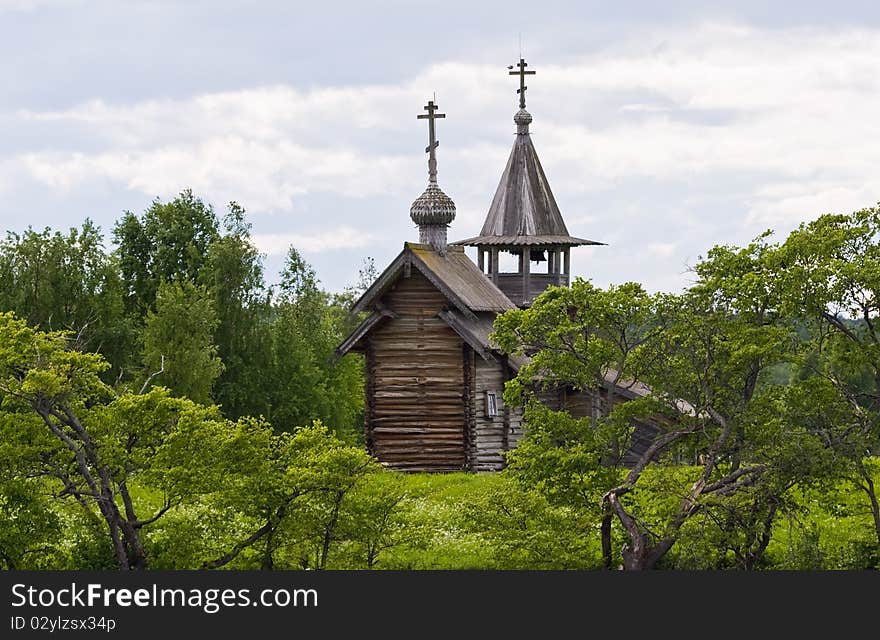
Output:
[0, 191, 381, 569]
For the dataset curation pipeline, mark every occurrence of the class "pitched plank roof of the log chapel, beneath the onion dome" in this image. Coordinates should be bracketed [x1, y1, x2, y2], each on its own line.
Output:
[352, 242, 516, 317]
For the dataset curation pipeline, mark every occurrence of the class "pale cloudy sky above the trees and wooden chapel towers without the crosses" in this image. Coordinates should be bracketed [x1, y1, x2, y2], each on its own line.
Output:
[0, 0, 880, 291]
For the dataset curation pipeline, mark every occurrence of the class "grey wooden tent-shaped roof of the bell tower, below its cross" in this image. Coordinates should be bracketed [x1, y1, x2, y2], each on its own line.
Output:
[454, 129, 603, 245]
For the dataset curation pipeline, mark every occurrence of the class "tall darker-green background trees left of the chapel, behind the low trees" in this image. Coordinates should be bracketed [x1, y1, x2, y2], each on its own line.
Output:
[0, 191, 373, 439]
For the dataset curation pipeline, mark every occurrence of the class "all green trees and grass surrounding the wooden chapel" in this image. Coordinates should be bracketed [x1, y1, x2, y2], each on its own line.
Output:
[0, 192, 880, 570]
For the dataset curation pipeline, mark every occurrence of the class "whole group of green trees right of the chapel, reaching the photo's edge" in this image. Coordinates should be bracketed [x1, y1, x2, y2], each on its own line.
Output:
[495, 202, 880, 569]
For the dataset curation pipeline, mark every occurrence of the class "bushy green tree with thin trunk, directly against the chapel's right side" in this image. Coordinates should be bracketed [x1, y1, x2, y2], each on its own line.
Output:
[495, 279, 663, 569]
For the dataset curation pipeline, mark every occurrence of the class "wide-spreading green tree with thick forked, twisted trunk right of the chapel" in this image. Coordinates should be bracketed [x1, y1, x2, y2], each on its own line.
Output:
[495, 264, 804, 569]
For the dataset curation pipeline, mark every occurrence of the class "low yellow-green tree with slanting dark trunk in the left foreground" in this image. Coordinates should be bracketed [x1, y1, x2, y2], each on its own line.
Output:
[0, 313, 226, 569]
